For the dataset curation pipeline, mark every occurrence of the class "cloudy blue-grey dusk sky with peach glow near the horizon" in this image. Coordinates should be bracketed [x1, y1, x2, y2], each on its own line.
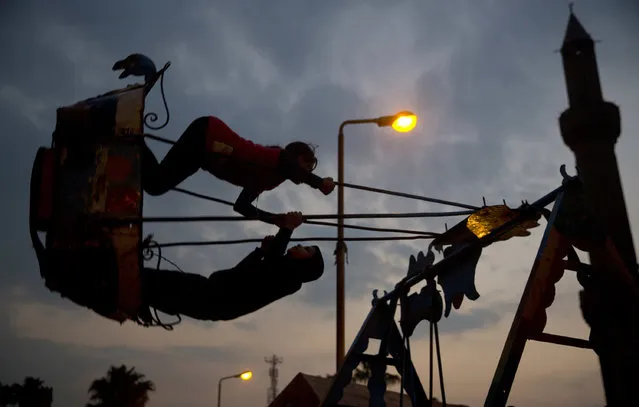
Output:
[0, 0, 639, 407]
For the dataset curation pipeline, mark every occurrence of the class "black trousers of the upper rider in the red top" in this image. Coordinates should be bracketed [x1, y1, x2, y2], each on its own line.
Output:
[140, 117, 208, 196]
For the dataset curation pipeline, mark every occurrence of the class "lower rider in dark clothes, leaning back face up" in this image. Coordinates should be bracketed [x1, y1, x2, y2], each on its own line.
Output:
[142, 212, 324, 321]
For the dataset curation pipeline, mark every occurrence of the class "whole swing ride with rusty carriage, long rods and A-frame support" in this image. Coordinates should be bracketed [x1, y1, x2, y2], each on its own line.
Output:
[29, 8, 636, 407]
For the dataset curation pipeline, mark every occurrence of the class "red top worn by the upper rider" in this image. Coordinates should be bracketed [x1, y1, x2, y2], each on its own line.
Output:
[205, 116, 285, 192]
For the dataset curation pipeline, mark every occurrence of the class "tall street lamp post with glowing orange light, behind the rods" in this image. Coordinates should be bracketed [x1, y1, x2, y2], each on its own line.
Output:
[335, 111, 417, 372]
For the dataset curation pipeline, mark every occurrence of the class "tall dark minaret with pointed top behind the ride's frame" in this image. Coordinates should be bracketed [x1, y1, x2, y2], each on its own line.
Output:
[559, 9, 639, 407]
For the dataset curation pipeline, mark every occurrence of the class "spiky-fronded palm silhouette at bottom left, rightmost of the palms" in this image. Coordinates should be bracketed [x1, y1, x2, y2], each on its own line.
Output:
[86, 365, 155, 407]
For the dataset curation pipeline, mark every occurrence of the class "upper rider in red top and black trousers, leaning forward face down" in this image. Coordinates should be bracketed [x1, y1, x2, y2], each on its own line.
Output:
[141, 116, 335, 226]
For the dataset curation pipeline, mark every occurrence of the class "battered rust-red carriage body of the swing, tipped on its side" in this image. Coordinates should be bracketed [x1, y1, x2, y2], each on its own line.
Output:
[30, 85, 147, 323]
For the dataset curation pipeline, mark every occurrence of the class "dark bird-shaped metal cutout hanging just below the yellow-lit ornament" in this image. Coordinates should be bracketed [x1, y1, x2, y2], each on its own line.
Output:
[437, 244, 482, 317]
